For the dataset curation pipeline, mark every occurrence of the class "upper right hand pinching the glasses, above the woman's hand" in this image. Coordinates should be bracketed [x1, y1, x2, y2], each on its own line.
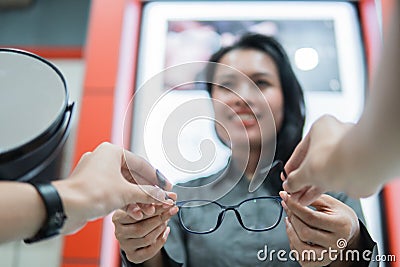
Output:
[283, 115, 353, 205]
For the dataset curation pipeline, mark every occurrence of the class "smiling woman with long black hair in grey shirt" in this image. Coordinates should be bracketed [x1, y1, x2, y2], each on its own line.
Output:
[113, 34, 375, 266]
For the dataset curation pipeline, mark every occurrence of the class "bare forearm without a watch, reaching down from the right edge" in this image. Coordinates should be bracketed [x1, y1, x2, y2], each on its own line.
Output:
[327, 1, 400, 192]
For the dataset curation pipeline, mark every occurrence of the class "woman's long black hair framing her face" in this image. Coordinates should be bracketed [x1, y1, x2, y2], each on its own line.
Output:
[206, 33, 305, 193]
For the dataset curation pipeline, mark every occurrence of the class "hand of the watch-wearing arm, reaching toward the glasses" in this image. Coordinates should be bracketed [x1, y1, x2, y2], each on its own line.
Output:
[53, 143, 176, 233]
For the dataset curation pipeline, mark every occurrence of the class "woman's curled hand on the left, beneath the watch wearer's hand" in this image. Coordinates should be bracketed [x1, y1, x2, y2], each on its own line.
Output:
[113, 206, 178, 264]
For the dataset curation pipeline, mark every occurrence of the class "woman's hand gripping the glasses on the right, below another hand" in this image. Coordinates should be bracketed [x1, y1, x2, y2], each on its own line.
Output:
[280, 192, 360, 266]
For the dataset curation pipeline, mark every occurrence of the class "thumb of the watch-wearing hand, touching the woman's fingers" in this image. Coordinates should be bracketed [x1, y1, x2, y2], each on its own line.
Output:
[124, 183, 177, 206]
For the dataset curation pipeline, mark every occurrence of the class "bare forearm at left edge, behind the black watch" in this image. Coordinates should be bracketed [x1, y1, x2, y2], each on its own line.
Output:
[0, 182, 46, 243]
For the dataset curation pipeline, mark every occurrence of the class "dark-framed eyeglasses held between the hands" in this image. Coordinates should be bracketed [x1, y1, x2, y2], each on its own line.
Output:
[176, 161, 286, 234]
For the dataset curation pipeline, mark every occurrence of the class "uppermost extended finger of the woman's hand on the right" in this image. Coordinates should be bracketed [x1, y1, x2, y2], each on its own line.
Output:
[281, 192, 335, 232]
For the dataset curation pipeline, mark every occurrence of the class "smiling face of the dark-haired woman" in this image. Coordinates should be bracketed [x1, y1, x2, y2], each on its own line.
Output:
[211, 49, 284, 150]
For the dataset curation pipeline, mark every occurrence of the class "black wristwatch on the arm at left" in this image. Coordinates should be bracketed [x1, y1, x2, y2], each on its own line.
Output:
[24, 182, 67, 244]
